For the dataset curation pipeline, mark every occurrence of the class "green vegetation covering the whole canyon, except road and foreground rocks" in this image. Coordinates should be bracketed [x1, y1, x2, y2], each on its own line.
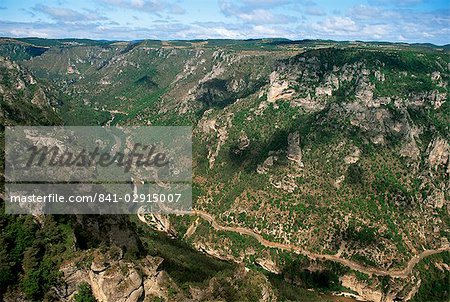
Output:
[0, 39, 450, 301]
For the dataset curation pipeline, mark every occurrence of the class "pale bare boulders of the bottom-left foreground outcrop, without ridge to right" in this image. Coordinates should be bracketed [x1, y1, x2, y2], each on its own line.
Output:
[57, 250, 185, 302]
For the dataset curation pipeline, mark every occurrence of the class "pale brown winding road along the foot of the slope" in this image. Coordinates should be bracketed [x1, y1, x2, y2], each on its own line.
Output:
[192, 210, 450, 278]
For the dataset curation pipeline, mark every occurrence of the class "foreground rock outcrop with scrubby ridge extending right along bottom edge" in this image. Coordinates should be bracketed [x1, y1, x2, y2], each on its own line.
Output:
[59, 248, 277, 302]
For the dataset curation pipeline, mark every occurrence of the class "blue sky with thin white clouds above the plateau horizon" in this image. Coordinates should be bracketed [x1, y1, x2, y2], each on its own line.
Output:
[0, 0, 450, 44]
